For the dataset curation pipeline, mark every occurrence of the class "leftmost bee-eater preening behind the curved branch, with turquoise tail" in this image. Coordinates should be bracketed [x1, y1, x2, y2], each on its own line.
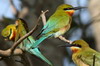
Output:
[2, 19, 52, 66]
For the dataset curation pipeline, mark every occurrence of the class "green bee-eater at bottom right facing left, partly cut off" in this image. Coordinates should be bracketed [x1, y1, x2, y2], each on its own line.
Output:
[59, 40, 100, 66]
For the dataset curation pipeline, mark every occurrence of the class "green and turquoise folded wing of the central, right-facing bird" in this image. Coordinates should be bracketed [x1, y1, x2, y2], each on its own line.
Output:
[42, 16, 71, 34]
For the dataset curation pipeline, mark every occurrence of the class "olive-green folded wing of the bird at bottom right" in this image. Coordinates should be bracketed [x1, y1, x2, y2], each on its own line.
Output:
[80, 50, 100, 66]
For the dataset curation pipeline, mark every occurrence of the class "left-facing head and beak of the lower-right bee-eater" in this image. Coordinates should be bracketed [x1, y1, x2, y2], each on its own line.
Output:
[58, 40, 89, 53]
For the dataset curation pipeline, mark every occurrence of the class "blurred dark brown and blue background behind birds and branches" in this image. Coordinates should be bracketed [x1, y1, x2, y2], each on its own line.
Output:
[0, 0, 100, 66]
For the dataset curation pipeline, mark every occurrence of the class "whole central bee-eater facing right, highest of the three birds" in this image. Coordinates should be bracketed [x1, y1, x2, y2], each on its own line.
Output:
[32, 4, 80, 48]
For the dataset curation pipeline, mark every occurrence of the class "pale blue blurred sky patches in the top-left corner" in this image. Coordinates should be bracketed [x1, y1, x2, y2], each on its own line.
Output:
[0, 0, 21, 19]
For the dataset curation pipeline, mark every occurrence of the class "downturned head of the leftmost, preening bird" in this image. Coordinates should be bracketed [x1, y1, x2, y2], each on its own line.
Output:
[1, 24, 17, 40]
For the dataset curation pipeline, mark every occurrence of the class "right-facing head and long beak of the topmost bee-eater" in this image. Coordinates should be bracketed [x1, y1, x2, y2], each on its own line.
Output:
[57, 4, 82, 16]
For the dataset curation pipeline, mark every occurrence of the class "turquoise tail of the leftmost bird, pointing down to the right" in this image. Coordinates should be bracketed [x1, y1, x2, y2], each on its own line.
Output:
[28, 48, 53, 66]
